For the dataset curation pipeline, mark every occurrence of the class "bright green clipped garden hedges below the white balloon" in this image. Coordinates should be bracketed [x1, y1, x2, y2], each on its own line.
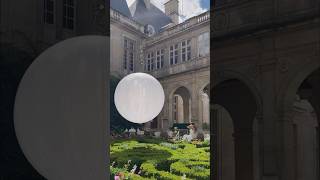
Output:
[110, 138, 210, 180]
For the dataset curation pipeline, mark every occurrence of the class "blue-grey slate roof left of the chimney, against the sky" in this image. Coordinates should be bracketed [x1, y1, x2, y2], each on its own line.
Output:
[130, 0, 172, 32]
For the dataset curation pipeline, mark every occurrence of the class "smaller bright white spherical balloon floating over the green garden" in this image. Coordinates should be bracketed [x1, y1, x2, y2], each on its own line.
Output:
[114, 73, 164, 123]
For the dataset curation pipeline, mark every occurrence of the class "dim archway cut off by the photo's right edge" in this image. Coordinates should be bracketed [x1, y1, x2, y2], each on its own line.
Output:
[277, 58, 320, 179]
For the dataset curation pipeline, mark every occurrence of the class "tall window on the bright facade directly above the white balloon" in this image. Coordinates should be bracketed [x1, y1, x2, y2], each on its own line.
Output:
[123, 38, 134, 71]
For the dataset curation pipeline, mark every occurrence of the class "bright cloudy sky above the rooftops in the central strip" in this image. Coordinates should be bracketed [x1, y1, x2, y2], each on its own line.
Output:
[127, 0, 210, 22]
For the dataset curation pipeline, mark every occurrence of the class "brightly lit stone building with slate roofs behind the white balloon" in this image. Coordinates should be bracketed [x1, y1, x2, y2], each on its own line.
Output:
[110, 0, 210, 130]
